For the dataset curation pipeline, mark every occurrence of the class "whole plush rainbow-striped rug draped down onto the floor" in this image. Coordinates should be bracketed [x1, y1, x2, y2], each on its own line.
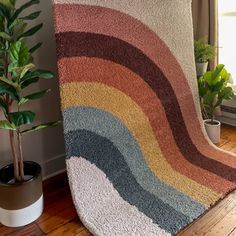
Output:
[54, 0, 236, 236]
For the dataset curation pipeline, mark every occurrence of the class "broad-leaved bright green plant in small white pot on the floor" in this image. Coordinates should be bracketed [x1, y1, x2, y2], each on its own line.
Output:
[198, 64, 234, 143]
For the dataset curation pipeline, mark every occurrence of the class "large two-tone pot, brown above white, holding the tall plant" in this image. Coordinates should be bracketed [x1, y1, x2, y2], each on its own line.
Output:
[0, 161, 43, 227]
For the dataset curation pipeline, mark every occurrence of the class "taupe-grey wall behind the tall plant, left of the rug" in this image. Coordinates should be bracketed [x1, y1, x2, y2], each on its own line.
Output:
[0, 0, 65, 177]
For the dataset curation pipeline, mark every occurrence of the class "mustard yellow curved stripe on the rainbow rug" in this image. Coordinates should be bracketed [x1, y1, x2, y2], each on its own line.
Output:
[61, 82, 221, 206]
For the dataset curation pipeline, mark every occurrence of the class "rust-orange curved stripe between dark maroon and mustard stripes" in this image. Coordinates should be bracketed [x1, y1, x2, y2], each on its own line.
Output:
[59, 57, 234, 192]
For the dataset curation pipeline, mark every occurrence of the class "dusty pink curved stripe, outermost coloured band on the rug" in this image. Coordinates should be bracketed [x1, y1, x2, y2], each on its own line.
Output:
[54, 4, 236, 168]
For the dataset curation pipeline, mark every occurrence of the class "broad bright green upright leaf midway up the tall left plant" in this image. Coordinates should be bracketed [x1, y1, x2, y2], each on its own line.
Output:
[9, 41, 30, 71]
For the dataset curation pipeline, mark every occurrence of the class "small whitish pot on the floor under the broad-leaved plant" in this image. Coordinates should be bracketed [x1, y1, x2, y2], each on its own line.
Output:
[204, 119, 221, 143]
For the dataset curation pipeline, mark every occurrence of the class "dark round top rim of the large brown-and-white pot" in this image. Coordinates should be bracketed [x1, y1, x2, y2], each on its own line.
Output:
[0, 161, 42, 187]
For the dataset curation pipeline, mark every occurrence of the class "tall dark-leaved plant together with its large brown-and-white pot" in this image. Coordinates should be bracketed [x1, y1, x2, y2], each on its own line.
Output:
[0, 0, 58, 227]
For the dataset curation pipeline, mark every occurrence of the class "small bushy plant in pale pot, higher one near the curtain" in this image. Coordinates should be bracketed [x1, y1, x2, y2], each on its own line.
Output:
[194, 39, 215, 77]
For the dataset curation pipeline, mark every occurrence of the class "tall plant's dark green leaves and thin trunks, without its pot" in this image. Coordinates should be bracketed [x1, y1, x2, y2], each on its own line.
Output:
[0, 0, 59, 181]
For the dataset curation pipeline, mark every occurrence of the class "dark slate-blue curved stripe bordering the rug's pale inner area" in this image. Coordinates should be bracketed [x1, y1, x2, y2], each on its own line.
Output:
[65, 130, 191, 233]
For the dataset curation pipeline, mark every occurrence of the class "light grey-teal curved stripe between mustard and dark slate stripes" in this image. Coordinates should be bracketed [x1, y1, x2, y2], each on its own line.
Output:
[63, 107, 207, 219]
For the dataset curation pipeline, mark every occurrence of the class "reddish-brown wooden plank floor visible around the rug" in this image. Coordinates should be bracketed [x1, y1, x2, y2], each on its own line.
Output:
[0, 126, 236, 236]
